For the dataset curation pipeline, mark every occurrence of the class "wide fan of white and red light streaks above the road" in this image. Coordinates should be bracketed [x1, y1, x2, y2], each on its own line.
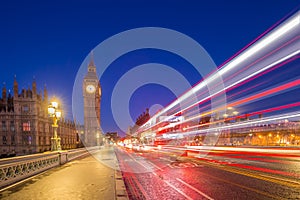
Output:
[132, 11, 300, 149]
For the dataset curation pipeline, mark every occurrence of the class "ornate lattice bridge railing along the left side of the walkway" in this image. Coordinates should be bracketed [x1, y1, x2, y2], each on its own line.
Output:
[0, 147, 99, 189]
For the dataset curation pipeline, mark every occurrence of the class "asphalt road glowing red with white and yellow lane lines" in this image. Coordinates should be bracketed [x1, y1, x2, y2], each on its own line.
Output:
[115, 148, 300, 200]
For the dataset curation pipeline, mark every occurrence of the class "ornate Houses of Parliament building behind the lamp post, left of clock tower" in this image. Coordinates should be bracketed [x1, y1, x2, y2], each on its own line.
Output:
[0, 78, 79, 157]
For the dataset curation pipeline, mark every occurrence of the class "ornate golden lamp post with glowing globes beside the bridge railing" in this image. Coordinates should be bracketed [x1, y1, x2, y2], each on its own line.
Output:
[48, 101, 61, 151]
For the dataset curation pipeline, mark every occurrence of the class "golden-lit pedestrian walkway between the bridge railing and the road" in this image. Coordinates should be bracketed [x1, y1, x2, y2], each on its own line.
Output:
[0, 147, 125, 200]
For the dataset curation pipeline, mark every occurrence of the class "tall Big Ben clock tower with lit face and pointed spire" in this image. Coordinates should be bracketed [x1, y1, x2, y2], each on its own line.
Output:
[82, 54, 102, 146]
